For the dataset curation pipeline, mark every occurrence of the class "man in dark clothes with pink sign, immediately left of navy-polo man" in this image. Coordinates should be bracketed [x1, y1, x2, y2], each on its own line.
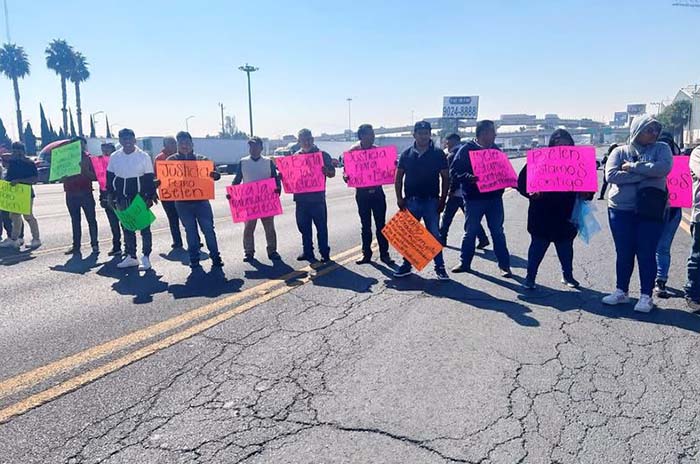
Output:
[343, 124, 396, 266]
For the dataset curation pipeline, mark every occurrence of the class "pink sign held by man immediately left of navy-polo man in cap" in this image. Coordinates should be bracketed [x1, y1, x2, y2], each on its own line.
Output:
[343, 146, 397, 187]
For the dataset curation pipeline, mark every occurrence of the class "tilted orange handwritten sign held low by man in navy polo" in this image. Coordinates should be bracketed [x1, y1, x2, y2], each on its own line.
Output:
[382, 210, 442, 271]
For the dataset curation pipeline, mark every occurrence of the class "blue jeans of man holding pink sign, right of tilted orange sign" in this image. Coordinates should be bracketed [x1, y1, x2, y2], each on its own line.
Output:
[461, 197, 510, 270]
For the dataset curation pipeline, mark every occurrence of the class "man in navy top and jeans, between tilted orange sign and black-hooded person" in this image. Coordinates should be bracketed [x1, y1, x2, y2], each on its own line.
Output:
[450, 120, 513, 278]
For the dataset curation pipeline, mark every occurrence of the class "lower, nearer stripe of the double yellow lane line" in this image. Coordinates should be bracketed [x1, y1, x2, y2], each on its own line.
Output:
[0, 246, 370, 424]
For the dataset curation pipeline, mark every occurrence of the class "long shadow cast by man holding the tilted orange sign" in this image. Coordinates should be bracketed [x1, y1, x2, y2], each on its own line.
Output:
[384, 274, 540, 327]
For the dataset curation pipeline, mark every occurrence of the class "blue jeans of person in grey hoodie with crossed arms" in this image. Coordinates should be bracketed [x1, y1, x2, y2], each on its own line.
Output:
[608, 208, 664, 296]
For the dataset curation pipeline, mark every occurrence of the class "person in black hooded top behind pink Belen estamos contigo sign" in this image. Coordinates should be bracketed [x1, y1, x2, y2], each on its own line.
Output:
[518, 129, 592, 290]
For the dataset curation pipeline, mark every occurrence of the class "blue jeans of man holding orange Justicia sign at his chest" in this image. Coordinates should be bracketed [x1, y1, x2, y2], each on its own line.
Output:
[175, 200, 221, 264]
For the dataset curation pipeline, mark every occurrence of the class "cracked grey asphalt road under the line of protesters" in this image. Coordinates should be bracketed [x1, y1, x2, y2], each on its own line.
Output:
[0, 162, 700, 463]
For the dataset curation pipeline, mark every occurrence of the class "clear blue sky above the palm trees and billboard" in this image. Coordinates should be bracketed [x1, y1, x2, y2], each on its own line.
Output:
[0, 0, 700, 137]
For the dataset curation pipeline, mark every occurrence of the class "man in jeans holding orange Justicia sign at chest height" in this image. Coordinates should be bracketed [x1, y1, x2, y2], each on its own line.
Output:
[166, 131, 224, 269]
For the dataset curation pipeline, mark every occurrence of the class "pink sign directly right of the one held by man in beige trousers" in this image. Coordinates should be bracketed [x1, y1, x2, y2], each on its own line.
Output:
[275, 151, 326, 193]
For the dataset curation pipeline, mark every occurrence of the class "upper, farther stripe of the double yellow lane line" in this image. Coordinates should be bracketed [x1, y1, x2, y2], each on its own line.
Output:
[0, 246, 361, 398]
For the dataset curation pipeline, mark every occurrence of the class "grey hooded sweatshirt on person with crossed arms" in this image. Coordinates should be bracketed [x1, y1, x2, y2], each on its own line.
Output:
[605, 114, 673, 211]
